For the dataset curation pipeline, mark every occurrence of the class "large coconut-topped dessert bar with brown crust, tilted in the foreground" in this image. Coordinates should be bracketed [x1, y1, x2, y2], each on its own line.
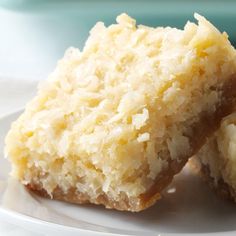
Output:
[5, 14, 236, 211]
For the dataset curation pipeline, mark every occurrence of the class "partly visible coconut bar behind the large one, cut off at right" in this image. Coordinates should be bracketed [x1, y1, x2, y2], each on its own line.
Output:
[194, 113, 236, 202]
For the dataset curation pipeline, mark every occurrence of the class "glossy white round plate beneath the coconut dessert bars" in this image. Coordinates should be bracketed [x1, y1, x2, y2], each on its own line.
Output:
[0, 112, 236, 236]
